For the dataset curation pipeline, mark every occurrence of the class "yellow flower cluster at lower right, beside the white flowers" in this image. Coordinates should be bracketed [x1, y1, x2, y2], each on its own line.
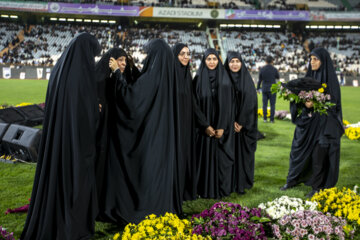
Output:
[311, 187, 360, 228]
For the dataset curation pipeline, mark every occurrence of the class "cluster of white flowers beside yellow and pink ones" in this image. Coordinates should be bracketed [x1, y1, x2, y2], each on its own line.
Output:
[258, 196, 317, 219]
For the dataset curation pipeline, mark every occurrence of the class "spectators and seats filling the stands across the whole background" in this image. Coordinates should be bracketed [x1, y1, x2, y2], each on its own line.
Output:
[0, 23, 360, 75]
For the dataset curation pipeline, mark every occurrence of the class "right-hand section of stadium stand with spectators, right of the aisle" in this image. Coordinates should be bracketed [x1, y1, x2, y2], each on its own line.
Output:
[221, 30, 360, 75]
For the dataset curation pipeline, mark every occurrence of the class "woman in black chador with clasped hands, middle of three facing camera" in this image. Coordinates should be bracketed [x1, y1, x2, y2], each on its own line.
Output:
[193, 48, 234, 198]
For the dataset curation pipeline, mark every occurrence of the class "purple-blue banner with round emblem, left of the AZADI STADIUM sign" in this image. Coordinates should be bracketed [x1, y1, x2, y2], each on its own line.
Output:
[48, 2, 139, 17]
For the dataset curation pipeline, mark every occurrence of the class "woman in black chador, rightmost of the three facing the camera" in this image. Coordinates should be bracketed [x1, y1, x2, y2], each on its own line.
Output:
[225, 52, 258, 193]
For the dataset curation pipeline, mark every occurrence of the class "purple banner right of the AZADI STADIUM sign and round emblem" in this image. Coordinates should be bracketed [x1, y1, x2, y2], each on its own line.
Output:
[226, 9, 310, 21]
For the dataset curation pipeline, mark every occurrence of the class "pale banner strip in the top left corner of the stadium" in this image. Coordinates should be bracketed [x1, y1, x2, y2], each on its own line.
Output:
[0, 1, 48, 12]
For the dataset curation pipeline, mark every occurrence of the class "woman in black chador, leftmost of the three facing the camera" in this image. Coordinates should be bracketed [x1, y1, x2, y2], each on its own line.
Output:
[172, 43, 196, 214]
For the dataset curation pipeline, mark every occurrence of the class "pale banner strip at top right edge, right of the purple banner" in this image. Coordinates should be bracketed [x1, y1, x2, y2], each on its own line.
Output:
[310, 11, 360, 21]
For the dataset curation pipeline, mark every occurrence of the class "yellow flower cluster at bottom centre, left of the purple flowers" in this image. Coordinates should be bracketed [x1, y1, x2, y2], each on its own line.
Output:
[117, 213, 211, 240]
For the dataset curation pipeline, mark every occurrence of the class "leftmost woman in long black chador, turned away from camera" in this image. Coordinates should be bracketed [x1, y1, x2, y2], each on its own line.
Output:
[21, 33, 101, 240]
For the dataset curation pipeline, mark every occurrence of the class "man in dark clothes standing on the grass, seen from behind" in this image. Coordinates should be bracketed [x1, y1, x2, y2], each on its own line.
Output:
[257, 56, 280, 123]
